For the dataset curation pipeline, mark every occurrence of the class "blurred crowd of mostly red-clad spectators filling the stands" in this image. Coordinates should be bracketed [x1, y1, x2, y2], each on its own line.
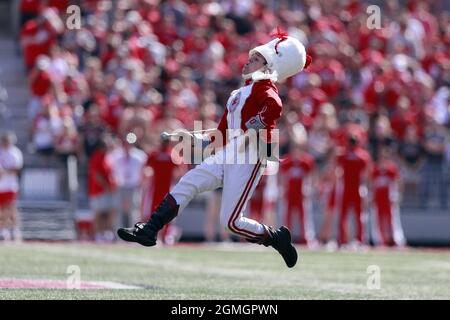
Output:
[15, 0, 450, 245]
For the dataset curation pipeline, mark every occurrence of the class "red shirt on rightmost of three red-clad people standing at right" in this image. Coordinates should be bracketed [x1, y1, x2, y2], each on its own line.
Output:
[372, 161, 399, 201]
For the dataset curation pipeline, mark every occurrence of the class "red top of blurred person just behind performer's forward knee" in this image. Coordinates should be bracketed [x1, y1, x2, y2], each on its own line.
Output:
[147, 150, 176, 210]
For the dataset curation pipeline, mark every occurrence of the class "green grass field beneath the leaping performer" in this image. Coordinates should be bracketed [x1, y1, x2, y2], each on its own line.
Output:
[0, 243, 450, 300]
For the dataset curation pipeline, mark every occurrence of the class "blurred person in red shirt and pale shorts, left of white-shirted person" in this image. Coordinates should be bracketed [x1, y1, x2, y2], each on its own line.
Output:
[88, 136, 117, 241]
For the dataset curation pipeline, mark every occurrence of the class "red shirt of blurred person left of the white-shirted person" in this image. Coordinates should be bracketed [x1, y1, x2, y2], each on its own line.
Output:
[88, 150, 116, 196]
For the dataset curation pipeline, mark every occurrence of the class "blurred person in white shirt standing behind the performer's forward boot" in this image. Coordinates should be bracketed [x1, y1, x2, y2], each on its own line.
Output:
[109, 136, 147, 227]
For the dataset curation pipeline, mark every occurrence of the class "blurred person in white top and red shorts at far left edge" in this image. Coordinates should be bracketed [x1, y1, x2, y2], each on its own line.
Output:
[0, 132, 23, 241]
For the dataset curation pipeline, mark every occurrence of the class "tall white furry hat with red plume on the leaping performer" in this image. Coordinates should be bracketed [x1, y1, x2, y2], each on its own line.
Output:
[249, 28, 311, 81]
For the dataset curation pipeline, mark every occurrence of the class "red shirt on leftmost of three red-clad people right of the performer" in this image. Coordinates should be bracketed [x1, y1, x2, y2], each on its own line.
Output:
[280, 153, 315, 199]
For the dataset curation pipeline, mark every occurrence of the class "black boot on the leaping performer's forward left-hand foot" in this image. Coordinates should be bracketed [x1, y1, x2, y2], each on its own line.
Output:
[117, 193, 180, 247]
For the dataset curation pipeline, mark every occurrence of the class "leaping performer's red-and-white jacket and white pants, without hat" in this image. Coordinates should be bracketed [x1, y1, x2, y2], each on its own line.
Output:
[170, 80, 281, 238]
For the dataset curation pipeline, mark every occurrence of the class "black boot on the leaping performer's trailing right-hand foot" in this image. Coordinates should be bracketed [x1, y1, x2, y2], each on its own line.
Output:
[247, 225, 298, 268]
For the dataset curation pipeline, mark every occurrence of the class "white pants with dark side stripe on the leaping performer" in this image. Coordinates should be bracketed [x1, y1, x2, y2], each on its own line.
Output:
[170, 138, 266, 239]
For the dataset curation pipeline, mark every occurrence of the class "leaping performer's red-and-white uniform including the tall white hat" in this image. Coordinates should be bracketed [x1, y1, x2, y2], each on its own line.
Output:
[170, 34, 311, 242]
